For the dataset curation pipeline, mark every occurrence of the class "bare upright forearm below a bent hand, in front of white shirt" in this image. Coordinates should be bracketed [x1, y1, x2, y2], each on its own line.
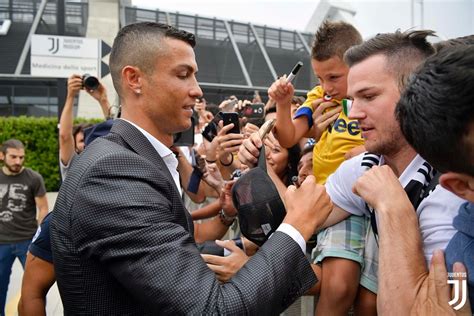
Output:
[377, 208, 428, 315]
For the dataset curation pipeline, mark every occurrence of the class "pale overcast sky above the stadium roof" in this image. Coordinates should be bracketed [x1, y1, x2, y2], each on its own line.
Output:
[132, 0, 474, 41]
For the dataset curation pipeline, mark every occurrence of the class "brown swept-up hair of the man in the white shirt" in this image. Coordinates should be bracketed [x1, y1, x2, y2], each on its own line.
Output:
[344, 30, 435, 91]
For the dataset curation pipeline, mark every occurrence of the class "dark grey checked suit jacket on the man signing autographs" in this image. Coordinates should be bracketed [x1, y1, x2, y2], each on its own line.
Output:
[51, 120, 316, 315]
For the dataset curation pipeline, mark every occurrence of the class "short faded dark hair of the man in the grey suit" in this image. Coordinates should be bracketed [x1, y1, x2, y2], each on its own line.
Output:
[109, 22, 196, 96]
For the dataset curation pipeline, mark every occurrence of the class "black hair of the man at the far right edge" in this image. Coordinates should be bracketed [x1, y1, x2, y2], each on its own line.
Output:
[396, 45, 474, 176]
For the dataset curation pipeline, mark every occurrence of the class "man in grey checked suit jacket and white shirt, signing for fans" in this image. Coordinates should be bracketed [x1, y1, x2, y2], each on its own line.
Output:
[51, 23, 331, 315]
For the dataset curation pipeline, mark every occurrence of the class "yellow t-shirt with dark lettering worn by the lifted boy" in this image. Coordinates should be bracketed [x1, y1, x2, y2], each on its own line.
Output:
[294, 86, 364, 184]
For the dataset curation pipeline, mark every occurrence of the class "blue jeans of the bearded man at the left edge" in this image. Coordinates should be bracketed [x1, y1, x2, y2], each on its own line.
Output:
[0, 240, 31, 315]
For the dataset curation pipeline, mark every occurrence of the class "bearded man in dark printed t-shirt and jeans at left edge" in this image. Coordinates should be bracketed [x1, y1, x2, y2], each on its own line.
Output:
[0, 139, 48, 315]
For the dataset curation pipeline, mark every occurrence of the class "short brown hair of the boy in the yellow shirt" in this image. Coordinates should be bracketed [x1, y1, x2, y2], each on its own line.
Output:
[311, 21, 362, 61]
